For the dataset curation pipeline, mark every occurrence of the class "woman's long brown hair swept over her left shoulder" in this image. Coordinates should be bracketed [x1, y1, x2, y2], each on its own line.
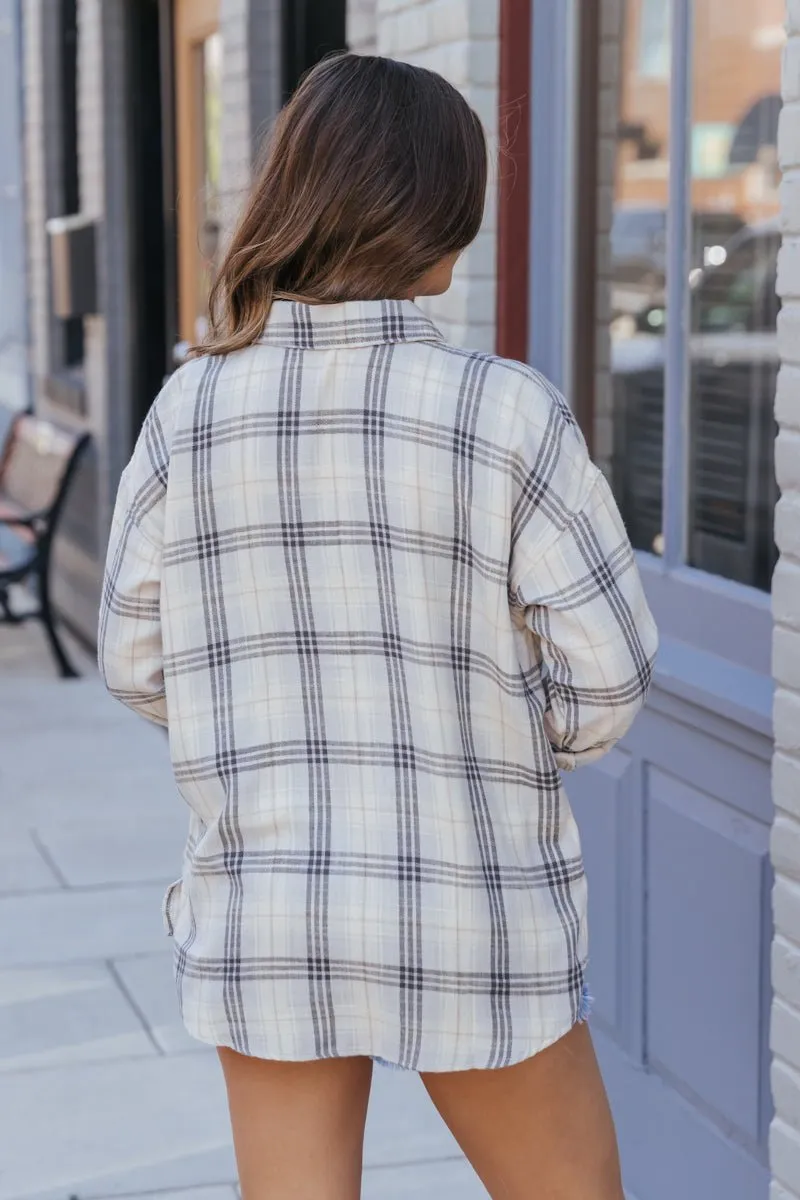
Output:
[192, 54, 487, 354]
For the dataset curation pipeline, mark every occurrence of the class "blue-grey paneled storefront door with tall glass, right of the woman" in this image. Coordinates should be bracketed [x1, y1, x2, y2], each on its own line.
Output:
[561, 0, 784, 1200]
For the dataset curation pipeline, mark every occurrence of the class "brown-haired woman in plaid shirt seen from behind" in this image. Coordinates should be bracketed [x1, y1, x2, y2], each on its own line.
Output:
[100, 55, 656, 1200]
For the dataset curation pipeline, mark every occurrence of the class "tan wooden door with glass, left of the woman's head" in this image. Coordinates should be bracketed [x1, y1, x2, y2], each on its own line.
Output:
[175, 0, 222, 342]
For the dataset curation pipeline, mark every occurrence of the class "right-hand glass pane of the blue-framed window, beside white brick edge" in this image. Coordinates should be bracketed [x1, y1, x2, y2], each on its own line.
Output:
[688, 0, 782, 589]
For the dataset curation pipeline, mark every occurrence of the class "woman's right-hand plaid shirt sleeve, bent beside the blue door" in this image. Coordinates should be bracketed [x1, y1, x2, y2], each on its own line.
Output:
[512, 374, 658, 770]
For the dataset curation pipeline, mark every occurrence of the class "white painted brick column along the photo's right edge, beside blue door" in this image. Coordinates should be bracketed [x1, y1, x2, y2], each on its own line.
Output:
[770, 0, 800, 1200]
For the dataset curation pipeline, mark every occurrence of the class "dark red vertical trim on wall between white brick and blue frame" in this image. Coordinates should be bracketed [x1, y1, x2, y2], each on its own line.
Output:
[497, 0, 533, 361]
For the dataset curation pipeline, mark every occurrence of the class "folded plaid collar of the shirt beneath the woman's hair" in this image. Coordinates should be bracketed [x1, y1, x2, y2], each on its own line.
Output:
[260, 300, 444, 350]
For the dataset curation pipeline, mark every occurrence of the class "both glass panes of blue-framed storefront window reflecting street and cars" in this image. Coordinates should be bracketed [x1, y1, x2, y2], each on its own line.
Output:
[612, 0, 783, 589]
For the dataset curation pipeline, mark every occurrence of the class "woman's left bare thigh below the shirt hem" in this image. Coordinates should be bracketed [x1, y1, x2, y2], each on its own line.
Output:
[219, 1049, 372, 1200]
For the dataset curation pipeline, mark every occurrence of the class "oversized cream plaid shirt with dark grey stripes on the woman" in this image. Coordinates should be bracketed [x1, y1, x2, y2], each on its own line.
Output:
[100, 301, 656, 1070]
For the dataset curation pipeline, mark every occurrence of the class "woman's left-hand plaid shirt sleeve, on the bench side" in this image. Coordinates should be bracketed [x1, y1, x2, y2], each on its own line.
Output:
[97, 376, 180, 725]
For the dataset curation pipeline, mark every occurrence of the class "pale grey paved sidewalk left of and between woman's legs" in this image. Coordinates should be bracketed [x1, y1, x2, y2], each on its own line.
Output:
[0, 626, 486, 1200]
